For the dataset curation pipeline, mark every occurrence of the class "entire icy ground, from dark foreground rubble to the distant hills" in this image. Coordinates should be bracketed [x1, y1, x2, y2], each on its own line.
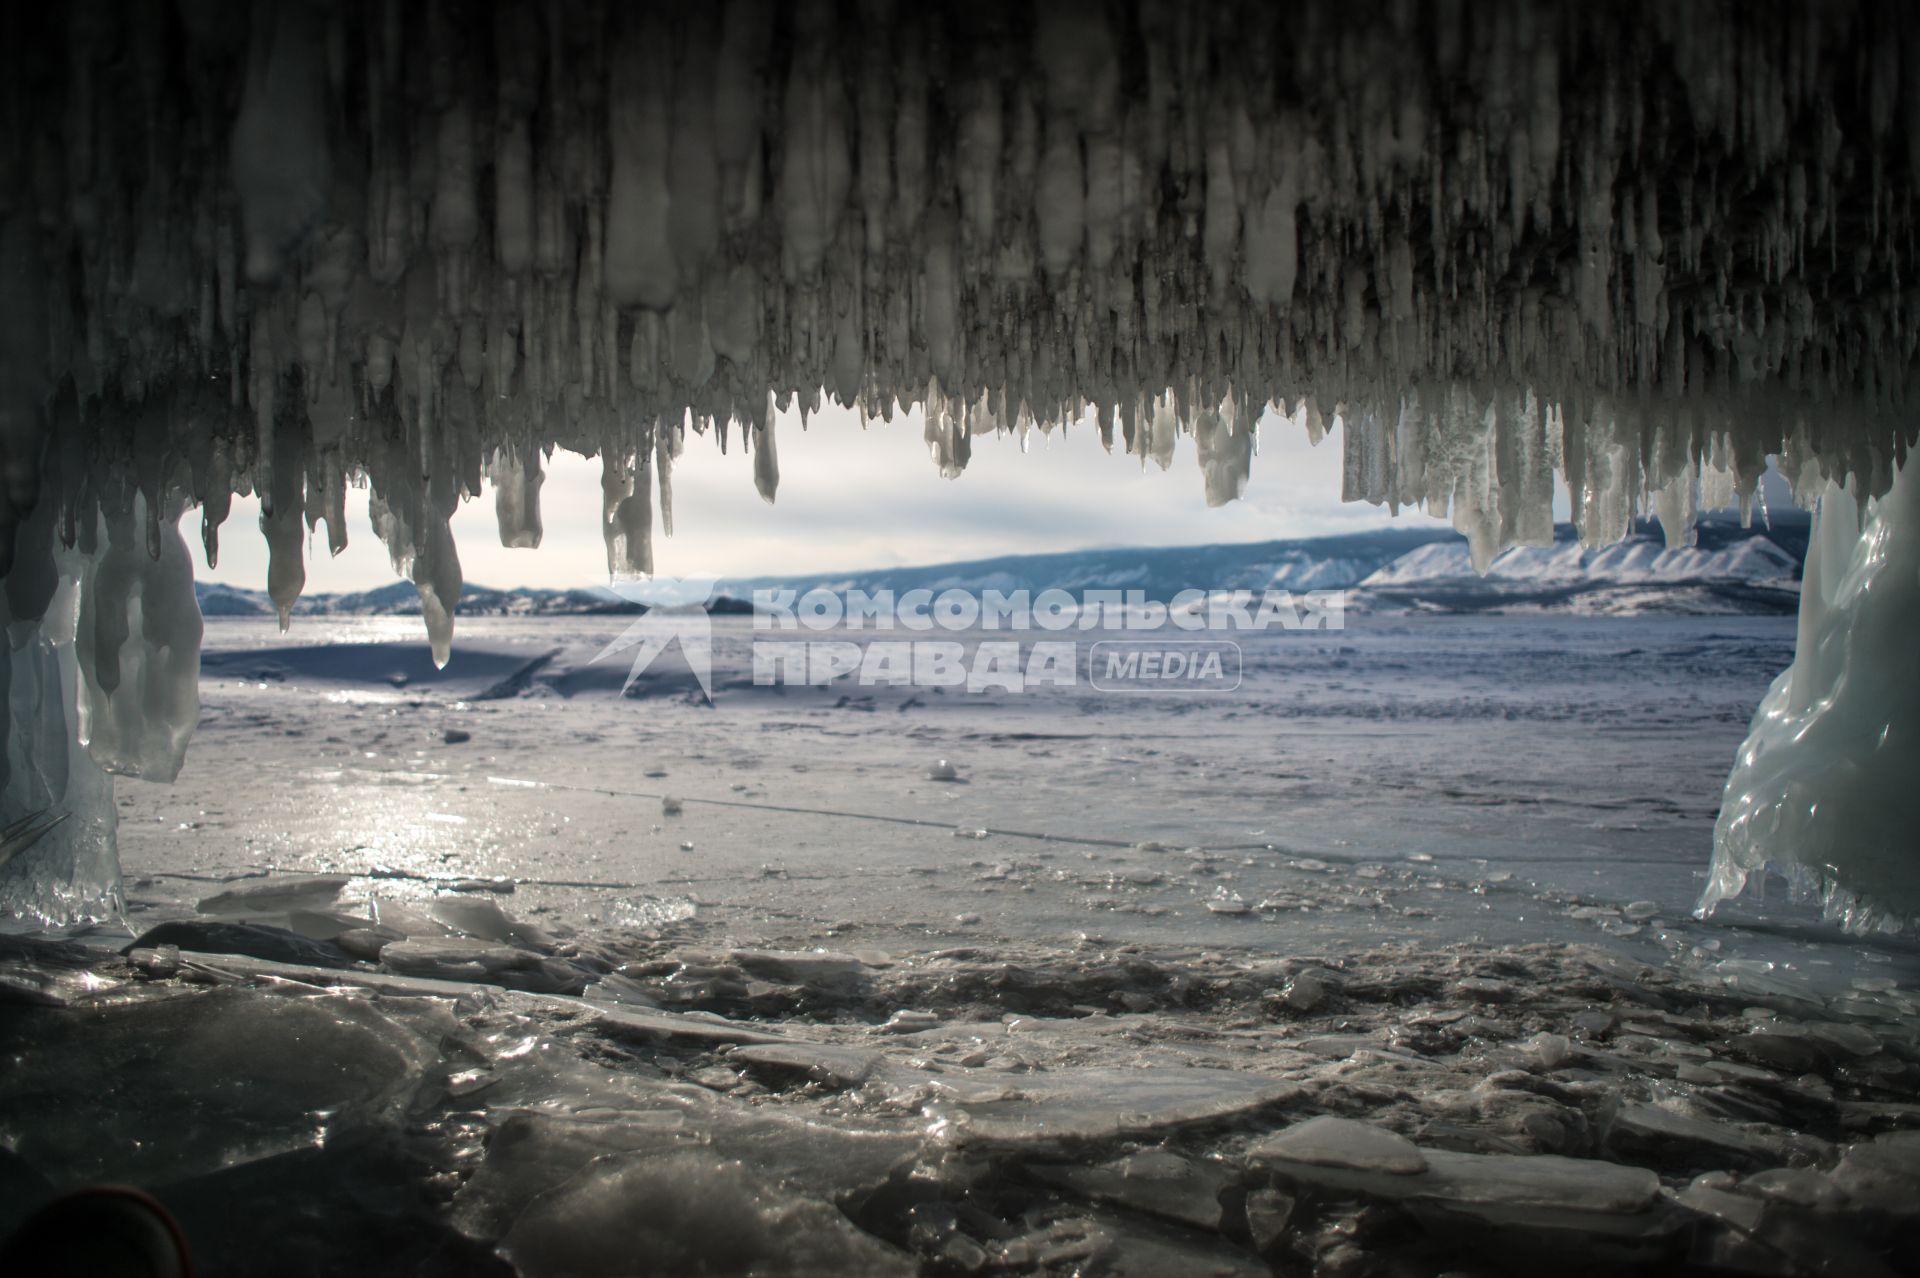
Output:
[0, 616, 1920, 1278]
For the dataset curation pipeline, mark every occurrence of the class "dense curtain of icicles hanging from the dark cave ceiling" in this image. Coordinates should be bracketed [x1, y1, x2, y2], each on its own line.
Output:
[0, 0, 1920, 917]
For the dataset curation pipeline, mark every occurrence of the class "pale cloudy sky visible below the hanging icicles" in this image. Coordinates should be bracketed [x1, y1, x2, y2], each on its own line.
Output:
[191, 407, 1436, 593]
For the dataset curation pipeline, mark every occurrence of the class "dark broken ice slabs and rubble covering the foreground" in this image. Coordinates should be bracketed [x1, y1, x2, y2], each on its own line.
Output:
[0, 909, 1920, 1276]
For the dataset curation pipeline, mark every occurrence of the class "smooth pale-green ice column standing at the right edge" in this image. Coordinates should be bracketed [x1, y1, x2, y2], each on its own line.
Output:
[1701, 461, 1920, 931]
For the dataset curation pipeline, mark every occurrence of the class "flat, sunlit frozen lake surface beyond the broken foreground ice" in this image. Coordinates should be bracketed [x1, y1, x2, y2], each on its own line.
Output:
[121, 616, 1889, 974]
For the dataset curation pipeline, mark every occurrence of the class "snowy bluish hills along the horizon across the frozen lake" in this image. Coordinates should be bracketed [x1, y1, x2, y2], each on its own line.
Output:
[196, 510, 1809, 616]
